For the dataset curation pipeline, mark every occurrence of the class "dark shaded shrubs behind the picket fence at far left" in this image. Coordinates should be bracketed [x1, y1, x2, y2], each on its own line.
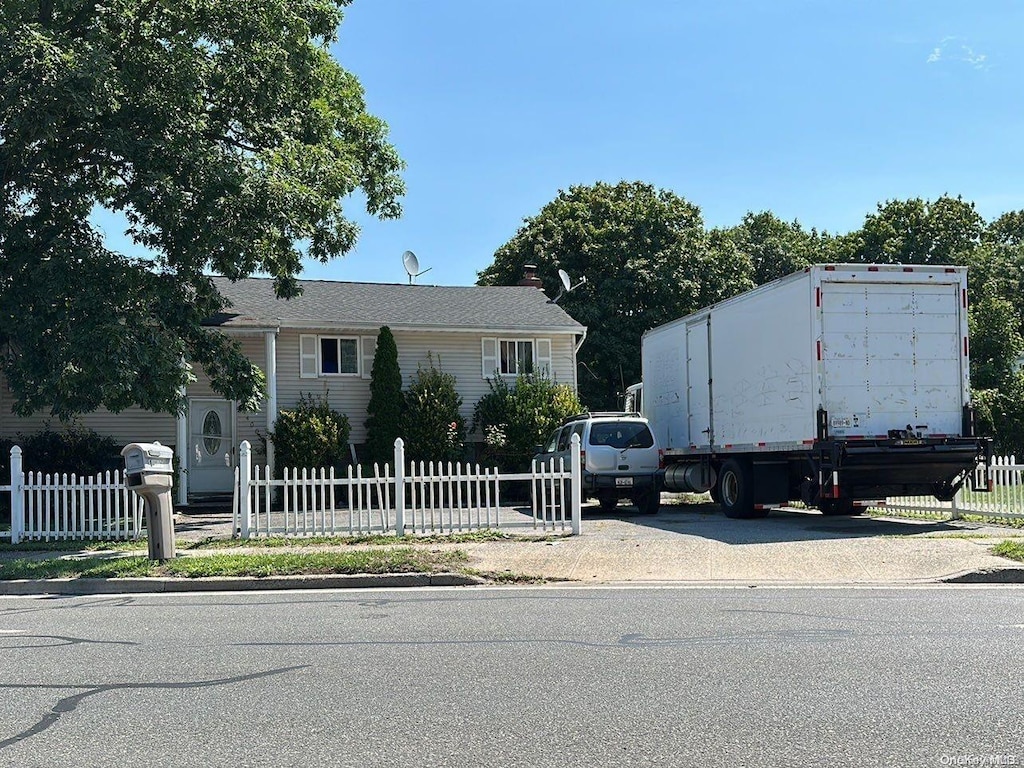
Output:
[0, 427, 124, 481]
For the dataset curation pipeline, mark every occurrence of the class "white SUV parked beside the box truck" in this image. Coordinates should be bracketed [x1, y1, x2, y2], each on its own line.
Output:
[534, 413, 660, 514]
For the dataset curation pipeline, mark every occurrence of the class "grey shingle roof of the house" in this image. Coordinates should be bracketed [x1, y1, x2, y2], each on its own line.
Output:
[208, 278, 584, 333]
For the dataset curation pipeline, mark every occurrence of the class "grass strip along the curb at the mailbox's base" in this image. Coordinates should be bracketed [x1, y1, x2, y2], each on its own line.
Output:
[0, 547, 468, 580]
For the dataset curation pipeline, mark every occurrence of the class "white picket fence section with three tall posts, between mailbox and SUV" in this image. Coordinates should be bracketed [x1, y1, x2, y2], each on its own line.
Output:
[233, 438, 581, 539]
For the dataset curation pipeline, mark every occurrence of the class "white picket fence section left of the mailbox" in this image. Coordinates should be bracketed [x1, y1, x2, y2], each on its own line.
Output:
[0, 445, 143, 544]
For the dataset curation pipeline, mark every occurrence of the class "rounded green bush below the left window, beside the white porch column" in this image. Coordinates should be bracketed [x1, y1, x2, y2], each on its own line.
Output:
[269, 393, 350, 476]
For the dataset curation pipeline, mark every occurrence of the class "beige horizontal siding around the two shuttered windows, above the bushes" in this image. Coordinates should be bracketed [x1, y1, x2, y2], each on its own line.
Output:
[278, 329, 575, 443]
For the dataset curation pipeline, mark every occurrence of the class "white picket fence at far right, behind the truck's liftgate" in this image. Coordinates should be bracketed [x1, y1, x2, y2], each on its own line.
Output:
[878, 456, 1024, 520]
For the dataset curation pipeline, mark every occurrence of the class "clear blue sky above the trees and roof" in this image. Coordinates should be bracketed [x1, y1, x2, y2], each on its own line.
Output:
[99, 0, 1024, 285]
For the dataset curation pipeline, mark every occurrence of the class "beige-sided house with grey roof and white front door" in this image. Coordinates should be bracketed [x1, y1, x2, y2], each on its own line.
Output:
[0, 278, 586, 504]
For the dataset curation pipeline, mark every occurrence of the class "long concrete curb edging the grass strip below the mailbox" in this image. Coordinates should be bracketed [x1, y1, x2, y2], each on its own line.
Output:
[0, 573, 488, 595]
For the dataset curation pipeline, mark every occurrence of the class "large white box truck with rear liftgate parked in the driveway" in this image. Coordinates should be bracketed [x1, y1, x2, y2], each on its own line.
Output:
[632, 264, 991, 517]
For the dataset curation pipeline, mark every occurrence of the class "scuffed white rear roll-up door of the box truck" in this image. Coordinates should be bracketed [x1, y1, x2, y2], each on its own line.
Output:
[820, 282, 966, 437]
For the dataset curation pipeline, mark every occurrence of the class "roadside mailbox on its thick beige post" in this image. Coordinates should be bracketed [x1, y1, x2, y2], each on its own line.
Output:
[121, 442, 174, 561]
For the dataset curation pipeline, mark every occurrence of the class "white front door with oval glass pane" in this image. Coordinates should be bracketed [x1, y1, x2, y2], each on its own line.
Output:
[187, 397, 234, 494]
